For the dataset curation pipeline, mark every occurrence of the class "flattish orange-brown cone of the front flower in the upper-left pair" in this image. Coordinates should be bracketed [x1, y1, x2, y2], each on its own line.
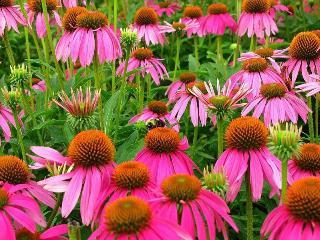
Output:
[76, 11, 108, 30]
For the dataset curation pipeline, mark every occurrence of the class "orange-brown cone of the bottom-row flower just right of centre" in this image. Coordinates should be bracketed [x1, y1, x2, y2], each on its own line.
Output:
[161, 174, 201, 203]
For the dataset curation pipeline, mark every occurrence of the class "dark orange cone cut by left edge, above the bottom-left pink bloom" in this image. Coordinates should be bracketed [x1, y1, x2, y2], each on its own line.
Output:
[0, 156, 30, 185]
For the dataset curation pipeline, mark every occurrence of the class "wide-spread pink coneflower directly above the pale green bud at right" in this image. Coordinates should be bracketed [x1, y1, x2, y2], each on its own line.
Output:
[242, 83, 311, 126]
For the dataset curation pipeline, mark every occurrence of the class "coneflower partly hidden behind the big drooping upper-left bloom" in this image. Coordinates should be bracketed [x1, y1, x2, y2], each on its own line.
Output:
[55, 7, 87, 62]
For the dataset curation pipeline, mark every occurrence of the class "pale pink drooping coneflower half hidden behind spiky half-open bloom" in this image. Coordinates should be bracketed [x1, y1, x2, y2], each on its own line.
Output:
[169, 81, 208, 126]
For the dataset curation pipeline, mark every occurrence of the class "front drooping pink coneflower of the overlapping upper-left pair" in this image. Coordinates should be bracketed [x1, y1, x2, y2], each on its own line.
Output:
[70, 11, 122, 67]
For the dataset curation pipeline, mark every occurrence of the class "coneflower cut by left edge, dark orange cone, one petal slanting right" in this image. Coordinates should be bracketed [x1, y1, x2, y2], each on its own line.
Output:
[0, 155, 56, 208]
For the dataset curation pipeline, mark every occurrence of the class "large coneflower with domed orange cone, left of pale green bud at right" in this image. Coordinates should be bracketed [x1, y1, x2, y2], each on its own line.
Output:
[215, 117, 281, 201]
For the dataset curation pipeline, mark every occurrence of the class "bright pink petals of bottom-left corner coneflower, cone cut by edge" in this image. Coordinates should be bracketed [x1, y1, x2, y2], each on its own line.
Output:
[0, 183, 46, 239]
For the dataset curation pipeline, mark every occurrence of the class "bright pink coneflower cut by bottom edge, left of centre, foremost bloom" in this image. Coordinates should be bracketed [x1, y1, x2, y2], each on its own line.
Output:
[88, 196, 192, 240]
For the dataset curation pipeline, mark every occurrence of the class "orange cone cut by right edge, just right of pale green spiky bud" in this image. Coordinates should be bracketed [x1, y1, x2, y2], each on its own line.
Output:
[293, 143, 320, 173]
